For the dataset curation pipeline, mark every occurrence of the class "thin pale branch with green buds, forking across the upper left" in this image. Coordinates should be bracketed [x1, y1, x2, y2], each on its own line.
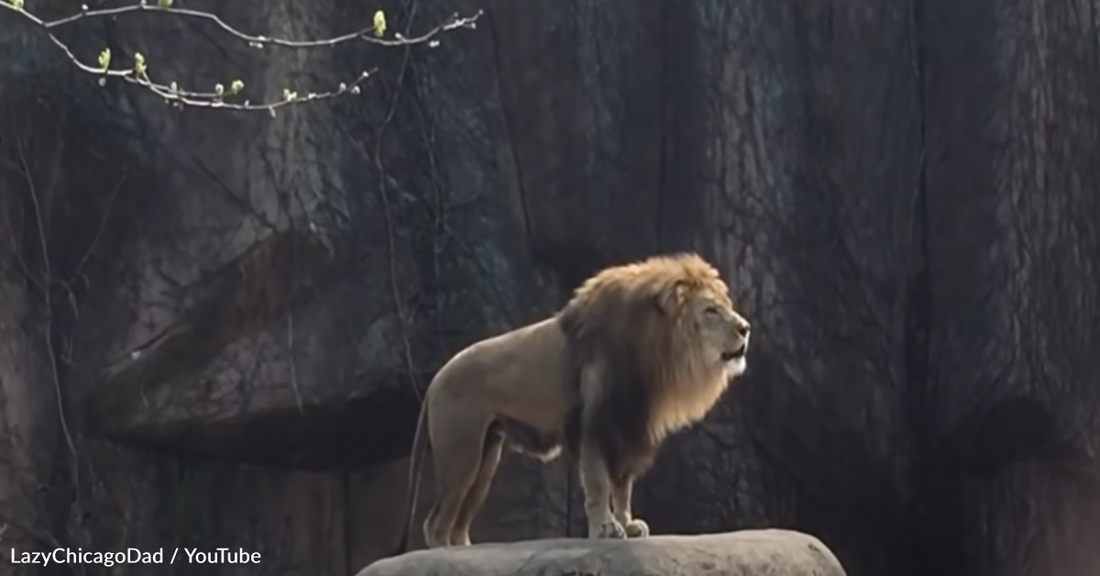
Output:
[0, 0, 482, 110]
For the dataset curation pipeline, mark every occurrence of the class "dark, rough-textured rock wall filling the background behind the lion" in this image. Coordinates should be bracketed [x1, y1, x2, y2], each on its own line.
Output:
[0, 0, 1100, 576]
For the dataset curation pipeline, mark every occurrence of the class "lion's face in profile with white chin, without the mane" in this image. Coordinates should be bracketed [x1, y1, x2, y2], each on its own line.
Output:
[691, 291, 749, 378]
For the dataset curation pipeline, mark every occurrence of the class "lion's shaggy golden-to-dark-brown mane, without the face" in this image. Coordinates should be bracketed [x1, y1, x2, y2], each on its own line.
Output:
[558, 253, 732, 477]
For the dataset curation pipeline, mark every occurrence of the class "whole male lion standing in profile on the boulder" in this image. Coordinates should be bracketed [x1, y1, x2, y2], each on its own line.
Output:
[398, 253, 750, 553]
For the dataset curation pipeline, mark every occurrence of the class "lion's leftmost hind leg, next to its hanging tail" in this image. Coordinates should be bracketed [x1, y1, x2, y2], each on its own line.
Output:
[424, 406, 492, 547]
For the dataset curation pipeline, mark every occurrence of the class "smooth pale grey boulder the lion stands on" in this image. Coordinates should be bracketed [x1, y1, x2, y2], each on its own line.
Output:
[356, 530, 845, 576]
